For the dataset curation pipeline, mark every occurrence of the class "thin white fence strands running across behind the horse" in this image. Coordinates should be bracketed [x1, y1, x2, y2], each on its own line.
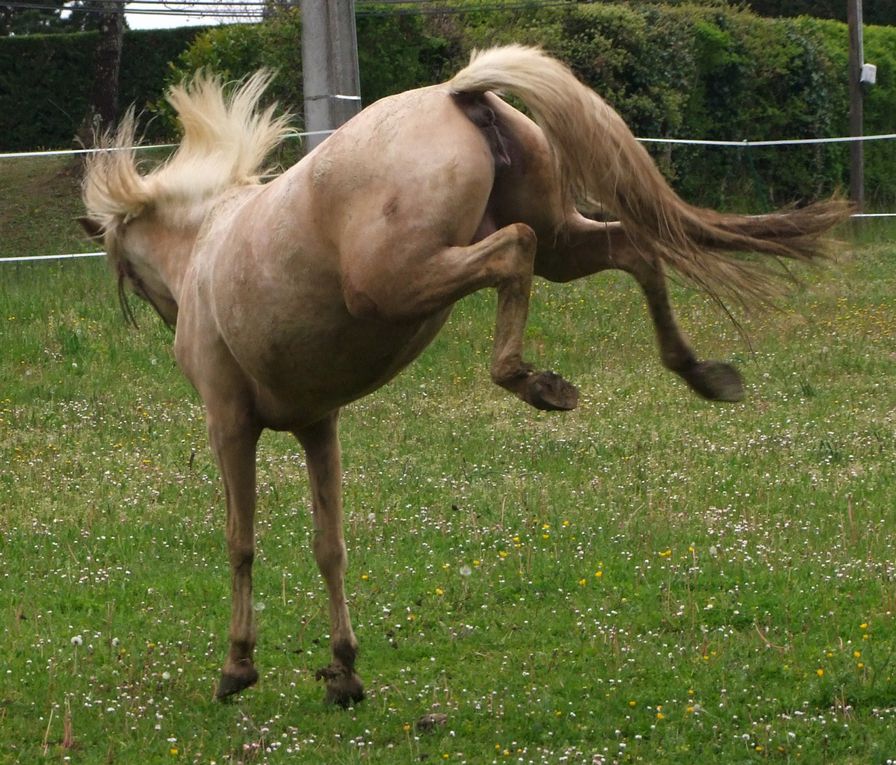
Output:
[0, 130, 896, 263]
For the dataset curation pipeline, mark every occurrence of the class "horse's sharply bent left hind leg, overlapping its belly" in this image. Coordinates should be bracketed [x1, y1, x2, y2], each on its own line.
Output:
[343, 223, 578, 410]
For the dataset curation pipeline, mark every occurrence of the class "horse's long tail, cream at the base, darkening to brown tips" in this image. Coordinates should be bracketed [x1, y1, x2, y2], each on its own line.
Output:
[448, 45, 851, 302]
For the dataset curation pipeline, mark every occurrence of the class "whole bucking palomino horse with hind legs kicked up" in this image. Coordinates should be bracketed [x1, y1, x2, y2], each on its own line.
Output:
[83, 46, 848, 705]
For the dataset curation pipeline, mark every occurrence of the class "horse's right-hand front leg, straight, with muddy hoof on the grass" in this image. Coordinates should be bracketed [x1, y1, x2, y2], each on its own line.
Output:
[295, 413, 364, 707]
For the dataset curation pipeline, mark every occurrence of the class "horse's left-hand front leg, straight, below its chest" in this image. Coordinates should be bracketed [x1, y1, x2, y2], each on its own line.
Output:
[208, 406, 261, 699]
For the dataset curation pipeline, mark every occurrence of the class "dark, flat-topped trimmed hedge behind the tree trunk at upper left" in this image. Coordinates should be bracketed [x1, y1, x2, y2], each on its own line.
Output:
[0, 27, 203, 151]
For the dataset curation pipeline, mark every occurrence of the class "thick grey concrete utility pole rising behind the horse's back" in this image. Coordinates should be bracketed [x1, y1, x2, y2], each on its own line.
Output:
[301, 0, 361, 151]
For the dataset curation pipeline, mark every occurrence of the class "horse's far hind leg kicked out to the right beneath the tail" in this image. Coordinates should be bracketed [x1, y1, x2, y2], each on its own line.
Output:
[535, 216, 744, 401]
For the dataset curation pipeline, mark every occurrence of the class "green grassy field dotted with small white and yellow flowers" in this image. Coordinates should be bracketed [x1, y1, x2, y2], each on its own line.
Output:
[0, 158, 896, 765]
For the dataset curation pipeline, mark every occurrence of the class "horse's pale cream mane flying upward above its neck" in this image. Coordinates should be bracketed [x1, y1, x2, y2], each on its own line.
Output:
[82, 71, 290, 232]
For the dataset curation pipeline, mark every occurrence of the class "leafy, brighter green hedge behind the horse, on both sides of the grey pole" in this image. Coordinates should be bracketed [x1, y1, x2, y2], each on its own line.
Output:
[0, 0, 896, 211]
